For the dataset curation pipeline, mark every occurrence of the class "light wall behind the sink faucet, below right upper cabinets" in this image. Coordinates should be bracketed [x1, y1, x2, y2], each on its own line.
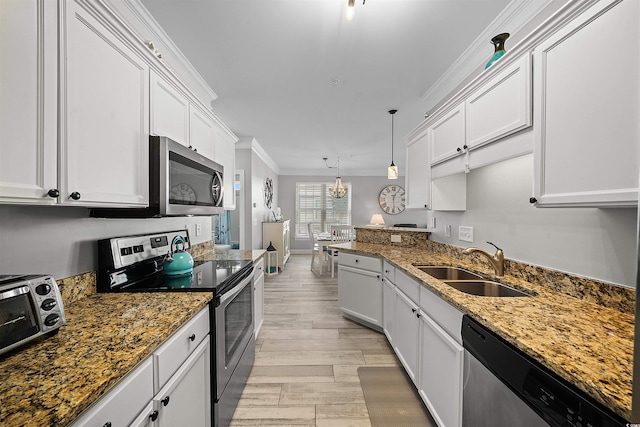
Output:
[428, 154, 637, 287]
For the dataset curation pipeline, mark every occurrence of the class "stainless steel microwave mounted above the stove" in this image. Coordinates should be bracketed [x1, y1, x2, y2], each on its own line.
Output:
[91, 136, 224, 218]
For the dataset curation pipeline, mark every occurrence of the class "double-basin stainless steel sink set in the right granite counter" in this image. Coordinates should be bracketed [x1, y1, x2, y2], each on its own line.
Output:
[415, 265, 531, 297]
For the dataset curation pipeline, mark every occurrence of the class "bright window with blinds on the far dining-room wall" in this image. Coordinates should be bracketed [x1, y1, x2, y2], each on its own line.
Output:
[296, 182, 351, 239]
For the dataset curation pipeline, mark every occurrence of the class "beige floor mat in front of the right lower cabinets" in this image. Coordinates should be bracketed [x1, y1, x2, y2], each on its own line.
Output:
[358, 367, 435, 427]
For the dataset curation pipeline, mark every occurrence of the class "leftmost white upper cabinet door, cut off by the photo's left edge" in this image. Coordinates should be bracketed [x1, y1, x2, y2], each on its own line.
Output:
[0, 0, 58, 204]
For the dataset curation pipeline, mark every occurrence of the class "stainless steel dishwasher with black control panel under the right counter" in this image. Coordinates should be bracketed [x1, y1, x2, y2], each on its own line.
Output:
[462, 315, 627, 427]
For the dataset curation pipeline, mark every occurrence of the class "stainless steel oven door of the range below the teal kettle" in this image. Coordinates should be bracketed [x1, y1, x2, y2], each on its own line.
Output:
[215, 275, 253, 399]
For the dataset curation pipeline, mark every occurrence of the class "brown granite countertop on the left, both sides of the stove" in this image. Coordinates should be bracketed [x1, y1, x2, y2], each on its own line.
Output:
[0, 250, 264, 427]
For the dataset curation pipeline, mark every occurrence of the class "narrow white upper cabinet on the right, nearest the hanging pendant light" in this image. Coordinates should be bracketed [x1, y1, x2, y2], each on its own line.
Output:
[404, 131, 431, 209]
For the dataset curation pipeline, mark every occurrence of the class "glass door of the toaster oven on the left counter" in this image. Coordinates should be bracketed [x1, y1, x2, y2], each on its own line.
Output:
[0, 286, 40, 354]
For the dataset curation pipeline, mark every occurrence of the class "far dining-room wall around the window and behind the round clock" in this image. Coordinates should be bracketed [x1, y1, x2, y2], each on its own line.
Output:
[278, 175, 427, 250]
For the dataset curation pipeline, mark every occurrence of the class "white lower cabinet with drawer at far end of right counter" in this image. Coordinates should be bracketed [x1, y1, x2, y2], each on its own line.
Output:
[338, 252, 382, 331]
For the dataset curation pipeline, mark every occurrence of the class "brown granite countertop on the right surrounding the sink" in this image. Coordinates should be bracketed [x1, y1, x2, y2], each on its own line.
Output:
[336, 242, 634, 420]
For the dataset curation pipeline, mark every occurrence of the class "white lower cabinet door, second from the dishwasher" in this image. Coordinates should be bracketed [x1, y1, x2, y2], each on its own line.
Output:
[393, 290, 420, 385]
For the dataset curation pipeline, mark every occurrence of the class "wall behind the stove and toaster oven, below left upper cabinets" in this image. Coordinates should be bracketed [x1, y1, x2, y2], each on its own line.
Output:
[0, 205, 212, 279]
